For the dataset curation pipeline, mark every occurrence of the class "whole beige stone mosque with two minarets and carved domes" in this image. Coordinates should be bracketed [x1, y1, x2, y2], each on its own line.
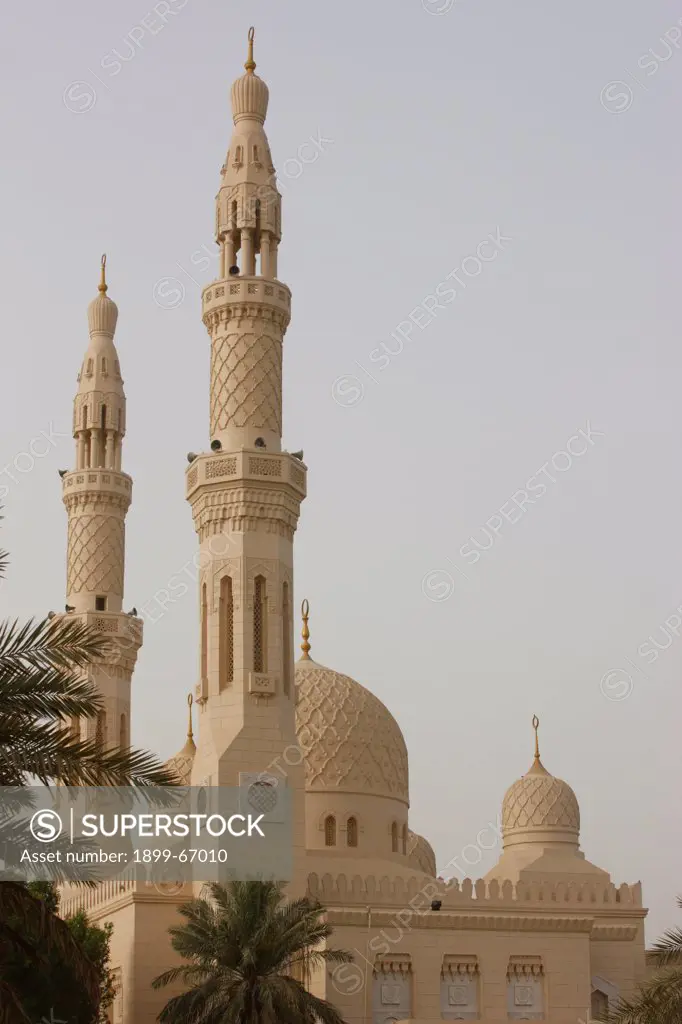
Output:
[55, 30, 646, 1024]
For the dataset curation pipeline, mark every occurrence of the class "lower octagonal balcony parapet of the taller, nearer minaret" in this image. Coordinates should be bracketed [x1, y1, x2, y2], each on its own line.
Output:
[185, 449, 307, 501]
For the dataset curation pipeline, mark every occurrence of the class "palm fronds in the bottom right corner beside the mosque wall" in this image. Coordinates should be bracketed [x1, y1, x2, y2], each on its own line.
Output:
[604, 897, 682, 1024]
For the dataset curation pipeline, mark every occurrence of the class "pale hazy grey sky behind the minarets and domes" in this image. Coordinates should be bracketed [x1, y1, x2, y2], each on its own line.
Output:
[0, 0, 682, 940]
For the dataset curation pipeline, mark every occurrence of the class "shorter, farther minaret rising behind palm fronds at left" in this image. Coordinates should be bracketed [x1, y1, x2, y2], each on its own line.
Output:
[62, 256, 142, 746]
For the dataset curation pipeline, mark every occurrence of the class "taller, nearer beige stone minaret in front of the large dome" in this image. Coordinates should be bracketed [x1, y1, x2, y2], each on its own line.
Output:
[186, 29, 306, 880]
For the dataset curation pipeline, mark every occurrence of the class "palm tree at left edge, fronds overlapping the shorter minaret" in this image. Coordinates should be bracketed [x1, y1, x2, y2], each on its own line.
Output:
[0, 551, 176, 1024]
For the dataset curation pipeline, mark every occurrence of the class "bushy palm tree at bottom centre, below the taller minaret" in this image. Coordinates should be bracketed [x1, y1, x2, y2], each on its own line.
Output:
[153, 882, 352, 1024]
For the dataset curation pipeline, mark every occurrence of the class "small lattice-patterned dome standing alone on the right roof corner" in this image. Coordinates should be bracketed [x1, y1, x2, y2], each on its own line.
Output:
[502, 757, 581, 841]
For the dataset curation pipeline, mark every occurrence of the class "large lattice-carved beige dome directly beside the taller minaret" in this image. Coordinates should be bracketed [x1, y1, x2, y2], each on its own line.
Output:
[296, 658, 410, 804]
